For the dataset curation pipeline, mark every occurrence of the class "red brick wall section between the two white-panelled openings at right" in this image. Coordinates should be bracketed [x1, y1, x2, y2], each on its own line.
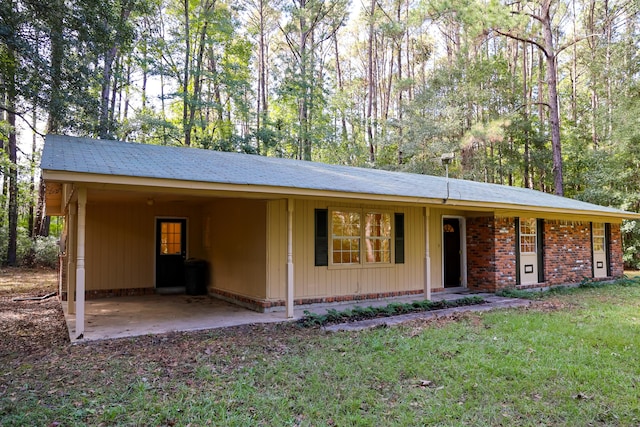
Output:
[544, 220, 593, 286]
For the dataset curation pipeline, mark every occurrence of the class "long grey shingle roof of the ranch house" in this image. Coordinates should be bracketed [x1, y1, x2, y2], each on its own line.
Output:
[41, 135, 636, 217]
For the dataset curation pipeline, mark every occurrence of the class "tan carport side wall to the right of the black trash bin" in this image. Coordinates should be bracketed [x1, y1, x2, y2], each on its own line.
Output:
[205, 199, 268, 299]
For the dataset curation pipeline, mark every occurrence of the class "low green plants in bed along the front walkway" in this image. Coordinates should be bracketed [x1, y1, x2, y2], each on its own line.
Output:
[298, 296, 486, 327]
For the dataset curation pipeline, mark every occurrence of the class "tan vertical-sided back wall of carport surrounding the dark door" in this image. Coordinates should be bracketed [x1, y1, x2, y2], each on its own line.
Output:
[85, 201, 204, 290]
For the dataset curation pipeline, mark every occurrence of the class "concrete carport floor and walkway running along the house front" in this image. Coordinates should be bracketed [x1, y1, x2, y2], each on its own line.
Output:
[62, 291, 529, 342]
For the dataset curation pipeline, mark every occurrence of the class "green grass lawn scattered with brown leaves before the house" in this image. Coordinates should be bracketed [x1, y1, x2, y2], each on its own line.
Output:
[0, 270, 640, 426]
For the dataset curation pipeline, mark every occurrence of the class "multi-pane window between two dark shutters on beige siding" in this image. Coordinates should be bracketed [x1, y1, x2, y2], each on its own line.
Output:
[329, 208, 392, 265]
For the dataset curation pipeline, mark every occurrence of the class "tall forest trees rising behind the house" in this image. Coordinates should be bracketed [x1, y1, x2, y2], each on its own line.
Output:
[0, 0, 640, 265]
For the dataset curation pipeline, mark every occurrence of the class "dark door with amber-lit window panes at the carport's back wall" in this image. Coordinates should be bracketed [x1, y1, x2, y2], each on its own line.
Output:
[156, 218, 187, 288]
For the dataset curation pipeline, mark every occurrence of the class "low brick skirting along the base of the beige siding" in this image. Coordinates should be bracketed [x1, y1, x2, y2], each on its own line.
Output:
[209, 289, 424, 312]
